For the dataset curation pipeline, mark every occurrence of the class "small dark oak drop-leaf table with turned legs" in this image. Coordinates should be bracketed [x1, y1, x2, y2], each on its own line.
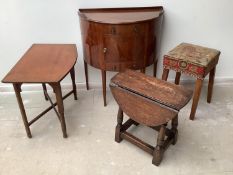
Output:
[110, 70, 192, 165]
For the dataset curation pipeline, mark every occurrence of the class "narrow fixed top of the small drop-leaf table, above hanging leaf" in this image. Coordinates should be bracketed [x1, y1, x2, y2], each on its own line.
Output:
[111, 70, 192, 111]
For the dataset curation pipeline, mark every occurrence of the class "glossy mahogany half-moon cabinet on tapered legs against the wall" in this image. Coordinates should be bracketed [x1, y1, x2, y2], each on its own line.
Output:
[79, 7, 163, 106]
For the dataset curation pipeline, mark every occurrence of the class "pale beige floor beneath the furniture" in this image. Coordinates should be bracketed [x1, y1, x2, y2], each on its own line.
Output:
[0, 85, 233, 175]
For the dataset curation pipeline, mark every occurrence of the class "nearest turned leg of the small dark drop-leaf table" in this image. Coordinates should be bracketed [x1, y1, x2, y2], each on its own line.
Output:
[152, 125, 166, 166]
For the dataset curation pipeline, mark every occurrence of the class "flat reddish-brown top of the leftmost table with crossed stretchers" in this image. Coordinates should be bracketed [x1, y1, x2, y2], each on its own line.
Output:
[2, 44, 78, 83]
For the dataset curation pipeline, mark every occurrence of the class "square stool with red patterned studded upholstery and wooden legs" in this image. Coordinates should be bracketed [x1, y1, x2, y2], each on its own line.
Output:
[162, 43, 220, 120]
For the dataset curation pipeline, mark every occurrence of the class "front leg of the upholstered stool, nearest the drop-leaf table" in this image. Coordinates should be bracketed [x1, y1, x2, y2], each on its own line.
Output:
[189, 79, 203, 120]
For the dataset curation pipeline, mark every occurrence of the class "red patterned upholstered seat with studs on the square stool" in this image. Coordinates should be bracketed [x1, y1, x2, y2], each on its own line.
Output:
[163, 43, 220, 79]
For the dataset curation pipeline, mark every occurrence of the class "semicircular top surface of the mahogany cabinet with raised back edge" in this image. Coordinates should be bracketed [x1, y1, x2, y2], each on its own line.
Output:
[79, 7, 163, 24]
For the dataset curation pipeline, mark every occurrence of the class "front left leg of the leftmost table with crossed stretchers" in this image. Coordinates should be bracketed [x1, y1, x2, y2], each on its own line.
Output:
[13, 84, 32, 138]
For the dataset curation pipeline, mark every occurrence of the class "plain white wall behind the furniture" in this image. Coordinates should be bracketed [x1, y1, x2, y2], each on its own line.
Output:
[0, 0, 233, 87]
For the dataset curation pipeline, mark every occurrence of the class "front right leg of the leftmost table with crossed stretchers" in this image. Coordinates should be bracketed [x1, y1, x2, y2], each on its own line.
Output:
[51, 83, 67, 138]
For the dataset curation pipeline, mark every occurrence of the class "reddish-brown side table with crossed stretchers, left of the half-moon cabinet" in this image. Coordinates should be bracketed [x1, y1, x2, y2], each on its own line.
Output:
[2, 44, 77, 138]
